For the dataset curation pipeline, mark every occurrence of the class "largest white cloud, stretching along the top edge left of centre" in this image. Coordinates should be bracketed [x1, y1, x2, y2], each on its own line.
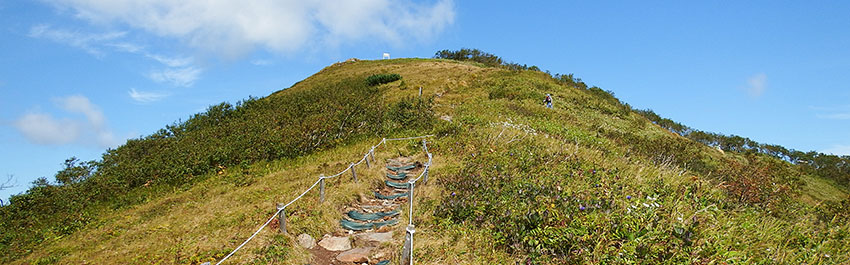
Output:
[49, 0, 455, 58]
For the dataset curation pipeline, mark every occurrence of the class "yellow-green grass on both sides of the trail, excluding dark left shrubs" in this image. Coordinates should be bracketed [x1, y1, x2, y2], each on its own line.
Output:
[12, 59, 850, 264]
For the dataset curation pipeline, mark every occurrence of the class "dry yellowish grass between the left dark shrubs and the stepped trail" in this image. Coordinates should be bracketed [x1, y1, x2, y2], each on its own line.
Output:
[16, 140, 408, 264]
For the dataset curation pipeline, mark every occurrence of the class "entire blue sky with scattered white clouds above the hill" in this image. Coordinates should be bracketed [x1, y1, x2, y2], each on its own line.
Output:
[0, 0, 850, 199]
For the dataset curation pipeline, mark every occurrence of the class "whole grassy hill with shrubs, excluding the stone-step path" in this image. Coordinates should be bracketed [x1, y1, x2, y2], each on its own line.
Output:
[0, 54, 850, 264]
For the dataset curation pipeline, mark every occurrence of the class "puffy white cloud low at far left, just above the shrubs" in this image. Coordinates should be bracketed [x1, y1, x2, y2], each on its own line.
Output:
[14, 96, 120, 148]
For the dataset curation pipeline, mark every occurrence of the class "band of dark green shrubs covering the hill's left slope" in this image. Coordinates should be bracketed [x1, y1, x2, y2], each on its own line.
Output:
[0, 79, 434, 261]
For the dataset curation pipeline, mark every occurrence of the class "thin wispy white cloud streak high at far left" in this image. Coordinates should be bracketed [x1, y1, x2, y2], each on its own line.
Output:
[29, 24, 126, 56]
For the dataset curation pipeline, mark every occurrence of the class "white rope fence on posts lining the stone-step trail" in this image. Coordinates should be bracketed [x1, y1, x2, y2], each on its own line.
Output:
[216, 135, 434, 265]
